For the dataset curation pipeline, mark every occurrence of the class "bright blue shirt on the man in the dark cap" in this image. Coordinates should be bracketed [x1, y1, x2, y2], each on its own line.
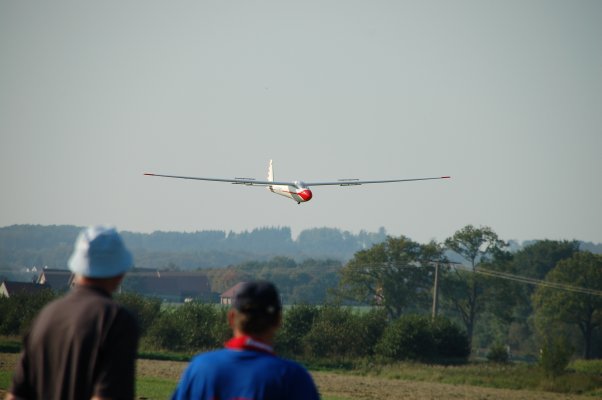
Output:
[172, 349, 320, 400]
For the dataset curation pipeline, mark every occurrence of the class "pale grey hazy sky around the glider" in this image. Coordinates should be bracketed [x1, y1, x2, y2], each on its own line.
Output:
[0, 0, 602, 242]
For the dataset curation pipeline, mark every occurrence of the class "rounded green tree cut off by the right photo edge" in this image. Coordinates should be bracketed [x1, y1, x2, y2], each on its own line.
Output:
[533, 252, 602, 359]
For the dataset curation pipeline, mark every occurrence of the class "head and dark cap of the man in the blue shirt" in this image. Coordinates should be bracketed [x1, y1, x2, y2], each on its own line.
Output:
[232, 281, 282, 335]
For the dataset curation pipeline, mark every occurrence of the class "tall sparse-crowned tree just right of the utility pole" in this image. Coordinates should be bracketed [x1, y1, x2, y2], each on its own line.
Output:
[442, 225, 506, 350]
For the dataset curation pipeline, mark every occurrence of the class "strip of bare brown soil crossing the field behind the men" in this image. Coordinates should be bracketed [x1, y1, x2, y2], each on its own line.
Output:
[0, 354, 592, 400]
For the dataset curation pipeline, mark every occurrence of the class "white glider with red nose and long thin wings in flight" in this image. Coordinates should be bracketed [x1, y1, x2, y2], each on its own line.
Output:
[144, 160, 450, 204]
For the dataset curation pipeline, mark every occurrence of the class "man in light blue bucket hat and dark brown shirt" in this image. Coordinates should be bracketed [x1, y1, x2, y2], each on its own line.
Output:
[7, 226, 139, 400]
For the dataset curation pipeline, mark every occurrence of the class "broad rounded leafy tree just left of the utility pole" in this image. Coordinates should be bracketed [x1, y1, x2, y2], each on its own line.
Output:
[338, 236, 443, 318]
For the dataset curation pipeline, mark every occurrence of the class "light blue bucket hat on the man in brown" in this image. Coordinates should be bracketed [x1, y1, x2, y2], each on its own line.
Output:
[68, 225, 134, 278]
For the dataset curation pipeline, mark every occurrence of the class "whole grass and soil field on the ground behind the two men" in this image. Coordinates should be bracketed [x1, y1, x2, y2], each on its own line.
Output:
[0, 352, 602, 400]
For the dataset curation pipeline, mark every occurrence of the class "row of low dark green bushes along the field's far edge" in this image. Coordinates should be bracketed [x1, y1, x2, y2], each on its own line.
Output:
[0, 292, 470, 362]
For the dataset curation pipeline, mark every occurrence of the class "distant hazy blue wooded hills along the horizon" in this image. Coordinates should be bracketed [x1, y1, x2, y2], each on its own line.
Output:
[0, 225, 387, 270]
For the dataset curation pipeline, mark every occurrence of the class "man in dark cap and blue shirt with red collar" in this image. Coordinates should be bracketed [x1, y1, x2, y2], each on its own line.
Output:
[172, 282, 320, 400]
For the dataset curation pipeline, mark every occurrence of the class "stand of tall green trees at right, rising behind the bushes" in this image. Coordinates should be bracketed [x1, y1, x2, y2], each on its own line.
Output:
[336, 225, 602, 359]
